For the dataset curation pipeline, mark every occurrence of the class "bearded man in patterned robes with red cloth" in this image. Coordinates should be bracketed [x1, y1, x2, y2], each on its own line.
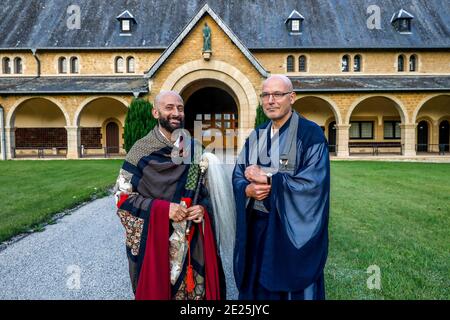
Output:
[115, 91, 225, 300]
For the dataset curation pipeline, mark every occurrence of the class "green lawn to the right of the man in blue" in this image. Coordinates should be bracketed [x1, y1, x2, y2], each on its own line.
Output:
[326, 161, 450, 299]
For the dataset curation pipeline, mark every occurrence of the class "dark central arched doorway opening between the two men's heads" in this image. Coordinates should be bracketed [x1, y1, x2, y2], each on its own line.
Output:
[183, 86, 239, 151]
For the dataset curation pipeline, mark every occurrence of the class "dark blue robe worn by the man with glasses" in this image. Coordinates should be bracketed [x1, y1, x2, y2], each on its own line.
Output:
[233, 112, 330, 300]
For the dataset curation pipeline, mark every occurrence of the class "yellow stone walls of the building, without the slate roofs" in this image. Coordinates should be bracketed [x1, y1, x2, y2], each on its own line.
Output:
[0, 9, 450, 159]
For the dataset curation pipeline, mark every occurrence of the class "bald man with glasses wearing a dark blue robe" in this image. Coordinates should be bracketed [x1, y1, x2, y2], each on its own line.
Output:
[233, 75, 330, 300]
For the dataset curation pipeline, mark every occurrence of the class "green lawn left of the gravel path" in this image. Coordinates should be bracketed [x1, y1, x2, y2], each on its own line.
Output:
[0, 160, 122, 242]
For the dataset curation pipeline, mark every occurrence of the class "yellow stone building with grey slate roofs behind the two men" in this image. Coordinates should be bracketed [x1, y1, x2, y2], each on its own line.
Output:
[0, 0, 450, 159]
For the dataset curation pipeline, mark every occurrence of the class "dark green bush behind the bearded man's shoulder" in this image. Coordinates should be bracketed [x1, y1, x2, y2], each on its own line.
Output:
[123, 99, 158, 152]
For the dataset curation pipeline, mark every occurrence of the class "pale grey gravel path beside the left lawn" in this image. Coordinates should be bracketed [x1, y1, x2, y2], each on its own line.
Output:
[0, 192, 237, 300]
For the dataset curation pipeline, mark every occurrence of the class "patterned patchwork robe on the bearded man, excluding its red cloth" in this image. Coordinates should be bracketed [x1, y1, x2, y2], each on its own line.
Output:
[115, 126, 224, 300]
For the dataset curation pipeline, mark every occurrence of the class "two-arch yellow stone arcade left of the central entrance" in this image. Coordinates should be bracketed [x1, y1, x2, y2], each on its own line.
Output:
[0, 97, 131, 159]
